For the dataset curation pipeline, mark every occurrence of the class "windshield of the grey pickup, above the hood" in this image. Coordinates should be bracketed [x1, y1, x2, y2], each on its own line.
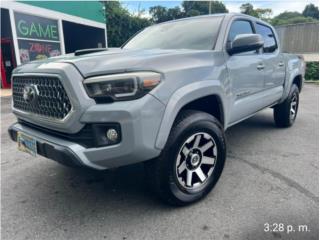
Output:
[123, 16, 222, 50]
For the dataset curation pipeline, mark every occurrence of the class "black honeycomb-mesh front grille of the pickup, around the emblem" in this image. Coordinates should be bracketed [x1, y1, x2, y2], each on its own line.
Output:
[12, 76, 71, 120]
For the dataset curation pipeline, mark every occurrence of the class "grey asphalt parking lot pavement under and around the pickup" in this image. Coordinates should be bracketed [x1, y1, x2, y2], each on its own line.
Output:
[1, 84, 319, 240]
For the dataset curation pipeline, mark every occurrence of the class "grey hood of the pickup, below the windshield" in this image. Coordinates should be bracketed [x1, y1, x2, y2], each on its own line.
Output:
[15, 49, 214, 77]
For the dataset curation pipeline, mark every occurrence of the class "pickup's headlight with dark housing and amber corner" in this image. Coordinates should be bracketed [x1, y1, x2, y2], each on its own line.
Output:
[83, 72, 161, 103]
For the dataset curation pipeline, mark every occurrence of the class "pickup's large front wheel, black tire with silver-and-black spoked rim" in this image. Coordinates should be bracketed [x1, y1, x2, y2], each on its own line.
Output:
[146, 110, 226, 206]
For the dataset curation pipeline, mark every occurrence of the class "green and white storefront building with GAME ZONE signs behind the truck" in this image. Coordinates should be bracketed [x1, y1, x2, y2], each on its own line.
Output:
[0, 1, 107, 88]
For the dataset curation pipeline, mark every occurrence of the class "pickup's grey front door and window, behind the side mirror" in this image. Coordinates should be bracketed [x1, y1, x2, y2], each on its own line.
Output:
[226, 18, 264, 125]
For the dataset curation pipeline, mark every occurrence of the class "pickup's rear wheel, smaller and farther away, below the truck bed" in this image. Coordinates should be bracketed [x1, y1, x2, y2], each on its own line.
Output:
[273, 84, 299, 128]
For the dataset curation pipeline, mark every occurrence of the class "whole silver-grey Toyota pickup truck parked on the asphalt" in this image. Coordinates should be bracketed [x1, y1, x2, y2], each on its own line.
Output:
[9, 14, 304, 205]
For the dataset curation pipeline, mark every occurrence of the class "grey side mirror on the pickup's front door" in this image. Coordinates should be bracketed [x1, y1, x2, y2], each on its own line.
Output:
[227, 34, 264, 55]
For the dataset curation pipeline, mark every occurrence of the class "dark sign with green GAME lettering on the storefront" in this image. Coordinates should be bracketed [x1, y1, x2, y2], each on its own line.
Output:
[14, 12, 59, 41]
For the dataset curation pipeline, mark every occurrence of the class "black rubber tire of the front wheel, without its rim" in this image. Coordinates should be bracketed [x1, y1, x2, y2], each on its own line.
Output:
[145, 110, 226, 206]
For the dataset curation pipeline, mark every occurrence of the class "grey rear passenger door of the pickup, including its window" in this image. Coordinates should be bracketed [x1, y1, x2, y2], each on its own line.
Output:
[255, 22, 285, 90]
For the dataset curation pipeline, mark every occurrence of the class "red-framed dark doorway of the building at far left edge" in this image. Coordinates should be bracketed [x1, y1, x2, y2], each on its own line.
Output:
[1, 39, 16, 88]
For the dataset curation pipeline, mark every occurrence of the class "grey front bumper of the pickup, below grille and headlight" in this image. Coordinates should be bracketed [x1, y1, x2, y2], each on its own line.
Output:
[9, 95, 165, 170]
